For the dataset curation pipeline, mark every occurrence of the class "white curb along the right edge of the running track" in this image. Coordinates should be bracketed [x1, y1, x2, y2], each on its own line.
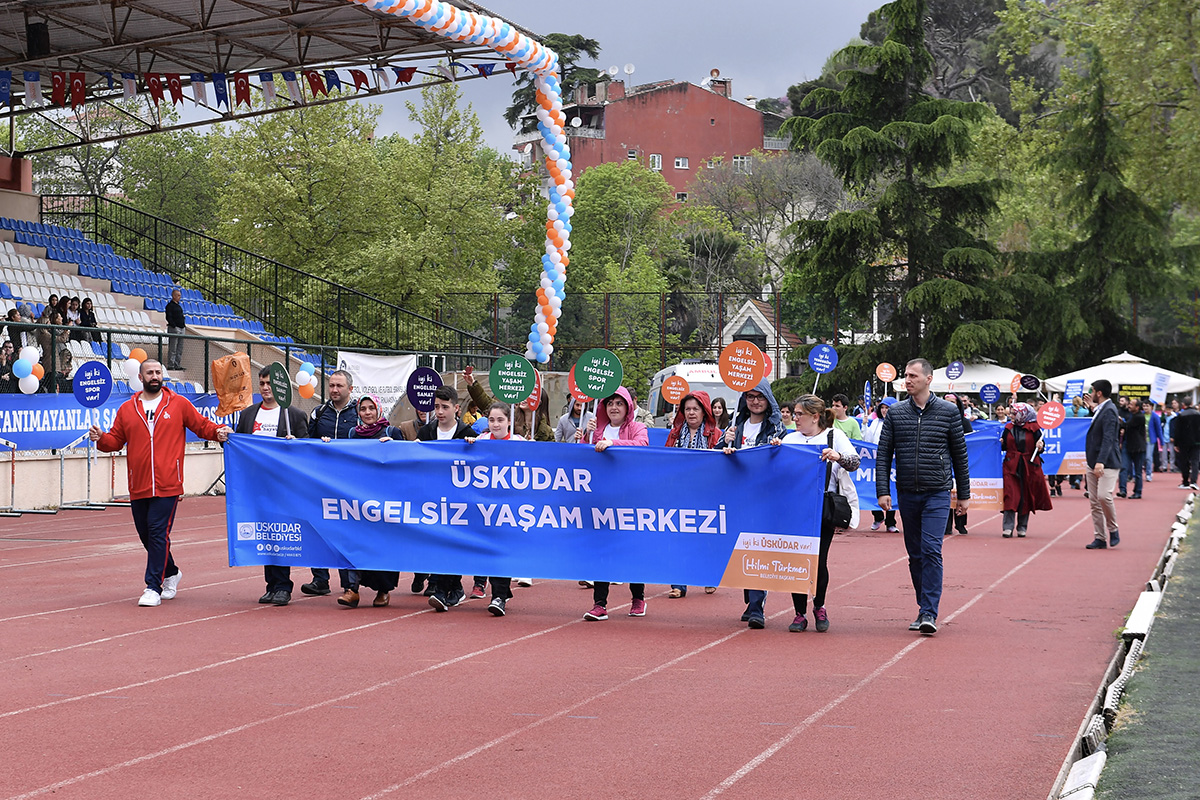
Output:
[1046, 494, 1195, 800]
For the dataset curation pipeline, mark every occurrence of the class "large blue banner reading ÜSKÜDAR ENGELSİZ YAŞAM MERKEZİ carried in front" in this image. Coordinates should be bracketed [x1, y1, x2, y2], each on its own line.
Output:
[224, 435, 824, 593]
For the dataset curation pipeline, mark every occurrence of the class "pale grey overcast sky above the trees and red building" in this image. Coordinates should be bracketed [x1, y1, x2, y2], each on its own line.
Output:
[374, 0, 882, 154]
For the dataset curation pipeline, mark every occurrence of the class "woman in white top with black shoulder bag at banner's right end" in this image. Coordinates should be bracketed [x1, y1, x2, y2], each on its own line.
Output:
[750, 395, 862, 633]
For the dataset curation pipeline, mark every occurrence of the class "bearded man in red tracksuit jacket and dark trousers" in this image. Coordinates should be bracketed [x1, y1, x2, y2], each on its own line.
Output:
[89, 359, 233, 606]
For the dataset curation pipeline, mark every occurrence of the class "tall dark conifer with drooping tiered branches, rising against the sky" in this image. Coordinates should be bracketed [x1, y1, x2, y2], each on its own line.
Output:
[785, 0, 1018, 361]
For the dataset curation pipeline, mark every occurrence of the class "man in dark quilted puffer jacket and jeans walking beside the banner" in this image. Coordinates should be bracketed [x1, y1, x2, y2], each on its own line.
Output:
[875, 359, 971, 636]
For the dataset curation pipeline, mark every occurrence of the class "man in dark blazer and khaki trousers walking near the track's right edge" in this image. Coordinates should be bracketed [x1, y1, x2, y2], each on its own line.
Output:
[1084, 379, 1121, 551]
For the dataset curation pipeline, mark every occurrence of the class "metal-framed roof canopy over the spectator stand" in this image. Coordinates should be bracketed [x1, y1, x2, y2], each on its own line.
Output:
[0, 0, 540, 152]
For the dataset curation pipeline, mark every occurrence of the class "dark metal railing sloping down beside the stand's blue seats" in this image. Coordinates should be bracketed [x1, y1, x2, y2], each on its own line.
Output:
[41, 194, 516, 356]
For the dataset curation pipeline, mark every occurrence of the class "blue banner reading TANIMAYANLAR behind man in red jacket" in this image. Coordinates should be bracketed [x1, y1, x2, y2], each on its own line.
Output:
[0, 392, 243, 450]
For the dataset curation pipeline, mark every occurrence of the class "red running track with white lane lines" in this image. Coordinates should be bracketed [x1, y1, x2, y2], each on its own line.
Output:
[0, 475, 1184, 800]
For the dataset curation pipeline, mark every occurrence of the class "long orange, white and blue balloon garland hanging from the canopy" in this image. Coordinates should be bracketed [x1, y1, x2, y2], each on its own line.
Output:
[348, 0, 575, 367]
